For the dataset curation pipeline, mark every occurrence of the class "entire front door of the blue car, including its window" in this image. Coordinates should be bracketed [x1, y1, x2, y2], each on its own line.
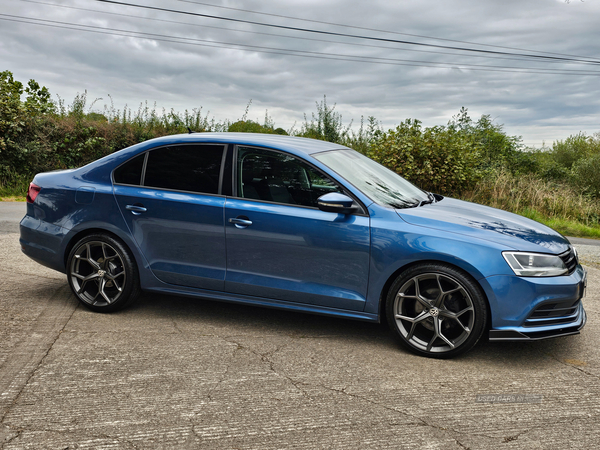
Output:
[225, 147, 370, 311]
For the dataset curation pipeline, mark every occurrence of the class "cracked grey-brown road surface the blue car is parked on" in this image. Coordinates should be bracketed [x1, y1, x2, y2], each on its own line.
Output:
[0, 204, 600, 450]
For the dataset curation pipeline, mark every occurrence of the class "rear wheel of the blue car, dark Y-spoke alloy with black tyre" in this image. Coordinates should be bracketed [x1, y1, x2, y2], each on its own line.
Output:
[67, 233, 140, 312]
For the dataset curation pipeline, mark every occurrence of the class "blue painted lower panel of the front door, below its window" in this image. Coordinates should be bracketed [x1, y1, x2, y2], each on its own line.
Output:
[225, 199, 370, 311]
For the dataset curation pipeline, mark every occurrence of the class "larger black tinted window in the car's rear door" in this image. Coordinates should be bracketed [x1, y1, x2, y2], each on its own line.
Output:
[144, 145, 224, 194]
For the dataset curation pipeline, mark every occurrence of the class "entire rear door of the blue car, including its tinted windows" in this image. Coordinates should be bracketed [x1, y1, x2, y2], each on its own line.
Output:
[114, 144, 226, 290]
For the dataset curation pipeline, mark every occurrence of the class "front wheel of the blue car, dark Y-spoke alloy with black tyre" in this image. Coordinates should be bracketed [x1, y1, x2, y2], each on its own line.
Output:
[386, 263, 488, 358]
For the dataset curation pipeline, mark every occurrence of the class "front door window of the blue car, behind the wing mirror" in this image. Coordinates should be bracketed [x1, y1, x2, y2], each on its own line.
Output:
[237, 147, 342, 208]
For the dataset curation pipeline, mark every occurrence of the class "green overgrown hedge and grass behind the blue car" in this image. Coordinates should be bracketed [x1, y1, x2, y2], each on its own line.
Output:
[0, 71, 600, 237]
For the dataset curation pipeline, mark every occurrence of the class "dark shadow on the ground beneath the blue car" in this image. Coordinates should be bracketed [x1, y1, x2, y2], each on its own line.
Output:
[116, 293, 582, 369]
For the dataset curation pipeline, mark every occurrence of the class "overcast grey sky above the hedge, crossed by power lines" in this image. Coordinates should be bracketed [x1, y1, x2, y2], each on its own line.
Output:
[0, 0, 600, 147]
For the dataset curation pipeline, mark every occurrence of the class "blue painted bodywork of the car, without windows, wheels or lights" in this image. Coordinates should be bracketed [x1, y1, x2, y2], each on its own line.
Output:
[20, 133, 585, 344]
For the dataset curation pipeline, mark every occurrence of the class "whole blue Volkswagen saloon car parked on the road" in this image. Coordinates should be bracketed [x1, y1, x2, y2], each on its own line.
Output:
[20, 133, 586, 358]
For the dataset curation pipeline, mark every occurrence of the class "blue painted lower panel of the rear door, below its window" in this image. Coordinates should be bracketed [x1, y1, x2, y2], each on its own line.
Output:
[114, 185, 226, 290]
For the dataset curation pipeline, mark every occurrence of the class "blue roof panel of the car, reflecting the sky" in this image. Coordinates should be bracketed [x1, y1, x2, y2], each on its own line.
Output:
[136, 133, 348, 155]
